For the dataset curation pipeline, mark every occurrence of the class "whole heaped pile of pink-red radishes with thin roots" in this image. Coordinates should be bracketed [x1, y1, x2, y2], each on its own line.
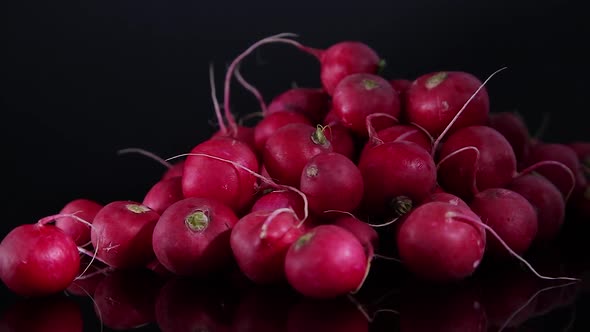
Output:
[0, 34, 590, 299]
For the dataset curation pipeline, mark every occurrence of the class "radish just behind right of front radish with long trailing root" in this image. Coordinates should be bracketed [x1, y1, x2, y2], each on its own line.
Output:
[469, 188, 538, 258]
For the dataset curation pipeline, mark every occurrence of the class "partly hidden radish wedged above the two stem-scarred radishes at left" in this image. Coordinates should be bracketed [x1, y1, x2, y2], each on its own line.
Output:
[142, 176, 184, 214]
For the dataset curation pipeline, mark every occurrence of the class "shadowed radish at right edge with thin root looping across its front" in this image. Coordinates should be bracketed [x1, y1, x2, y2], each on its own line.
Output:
[525, 143, 587, 197]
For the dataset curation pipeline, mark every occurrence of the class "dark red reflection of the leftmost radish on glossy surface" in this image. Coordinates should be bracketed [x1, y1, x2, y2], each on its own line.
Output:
[0, 294, 84, 332]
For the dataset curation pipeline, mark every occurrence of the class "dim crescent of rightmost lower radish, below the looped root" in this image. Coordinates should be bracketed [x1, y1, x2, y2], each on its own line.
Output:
[506, 174, 565, 244]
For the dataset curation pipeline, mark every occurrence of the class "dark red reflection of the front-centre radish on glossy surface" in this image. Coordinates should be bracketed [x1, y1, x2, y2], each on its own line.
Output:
[285, 297, 370, 332]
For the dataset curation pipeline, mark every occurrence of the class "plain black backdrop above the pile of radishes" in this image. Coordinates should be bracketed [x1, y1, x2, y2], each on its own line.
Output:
[0, 0, 590, 330]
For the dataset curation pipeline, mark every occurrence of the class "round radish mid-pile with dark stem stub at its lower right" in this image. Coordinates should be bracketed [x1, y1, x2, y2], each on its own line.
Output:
[358, 141, 436, 217]
